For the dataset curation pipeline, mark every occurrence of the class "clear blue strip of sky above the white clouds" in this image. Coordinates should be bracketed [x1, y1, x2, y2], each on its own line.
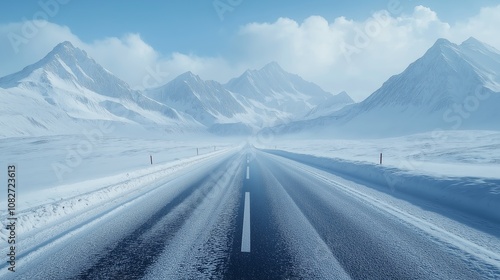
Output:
[0, 0, 498, 55]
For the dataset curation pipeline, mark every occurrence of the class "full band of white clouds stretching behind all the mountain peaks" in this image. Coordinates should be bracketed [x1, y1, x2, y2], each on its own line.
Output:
[0, 5, 500, 100]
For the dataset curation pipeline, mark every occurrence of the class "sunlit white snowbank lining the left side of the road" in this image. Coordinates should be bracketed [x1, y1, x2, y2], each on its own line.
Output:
[0, 146, 241, 238]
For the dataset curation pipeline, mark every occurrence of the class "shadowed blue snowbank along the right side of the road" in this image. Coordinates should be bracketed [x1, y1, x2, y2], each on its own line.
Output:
[263, 150, 500, 222]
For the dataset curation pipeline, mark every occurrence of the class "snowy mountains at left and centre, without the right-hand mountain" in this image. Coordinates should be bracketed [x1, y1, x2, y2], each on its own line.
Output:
[0, 42, 353, 137]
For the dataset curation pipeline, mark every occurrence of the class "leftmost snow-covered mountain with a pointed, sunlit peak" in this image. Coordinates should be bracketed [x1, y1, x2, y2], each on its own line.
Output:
[0, 42, 199, 136]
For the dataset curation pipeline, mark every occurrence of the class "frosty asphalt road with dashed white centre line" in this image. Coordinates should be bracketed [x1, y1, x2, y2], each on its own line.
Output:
[4, 148, 500, 279]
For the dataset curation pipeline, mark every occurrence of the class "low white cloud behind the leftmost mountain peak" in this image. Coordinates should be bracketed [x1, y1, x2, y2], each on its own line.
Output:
[0, 21, 234, 88]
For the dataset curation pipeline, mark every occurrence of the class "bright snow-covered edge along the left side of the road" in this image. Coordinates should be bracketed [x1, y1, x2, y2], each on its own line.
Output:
[0, 146, 241, 242]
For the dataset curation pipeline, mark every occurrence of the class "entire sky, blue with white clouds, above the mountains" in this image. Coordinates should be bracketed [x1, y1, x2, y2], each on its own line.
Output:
[0, 0, 500, 101]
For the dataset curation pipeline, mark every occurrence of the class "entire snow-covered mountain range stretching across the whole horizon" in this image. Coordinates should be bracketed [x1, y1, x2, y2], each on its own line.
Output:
[0, 38, 500, 137]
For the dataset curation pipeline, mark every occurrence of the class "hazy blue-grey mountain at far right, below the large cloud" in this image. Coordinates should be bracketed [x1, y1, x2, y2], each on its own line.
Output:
[362, 37, 500, 121]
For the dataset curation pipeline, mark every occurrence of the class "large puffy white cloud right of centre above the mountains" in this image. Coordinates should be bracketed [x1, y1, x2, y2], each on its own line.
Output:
[235, 6, 458, 100]
